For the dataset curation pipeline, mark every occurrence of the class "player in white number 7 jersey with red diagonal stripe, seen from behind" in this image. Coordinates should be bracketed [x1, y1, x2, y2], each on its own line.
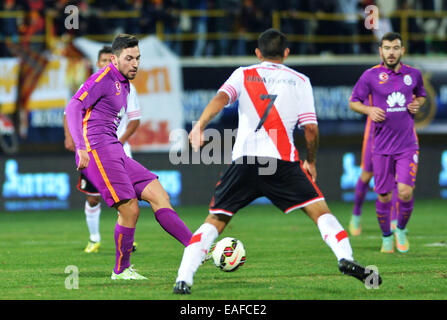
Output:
[174, 29, 381, 294]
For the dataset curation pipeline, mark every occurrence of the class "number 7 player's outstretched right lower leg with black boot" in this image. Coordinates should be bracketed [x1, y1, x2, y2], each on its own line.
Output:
[303, 200, 382, 284]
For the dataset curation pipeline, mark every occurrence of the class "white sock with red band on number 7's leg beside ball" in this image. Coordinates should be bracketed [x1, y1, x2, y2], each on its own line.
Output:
[176, 223, 219, 286]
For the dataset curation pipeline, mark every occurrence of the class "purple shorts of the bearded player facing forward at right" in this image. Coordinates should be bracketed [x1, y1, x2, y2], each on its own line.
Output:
[373, 150, 419, 194]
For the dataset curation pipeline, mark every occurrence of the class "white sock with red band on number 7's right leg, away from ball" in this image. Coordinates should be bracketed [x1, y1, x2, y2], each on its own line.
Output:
[317, 213, 354, 261]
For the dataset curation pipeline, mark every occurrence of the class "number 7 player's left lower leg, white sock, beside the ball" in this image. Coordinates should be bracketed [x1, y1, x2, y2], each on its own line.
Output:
[174, 214, 231, 294]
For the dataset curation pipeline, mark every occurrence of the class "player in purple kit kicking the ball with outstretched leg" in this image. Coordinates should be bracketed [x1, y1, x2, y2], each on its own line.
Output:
[66, 34, 192, 280]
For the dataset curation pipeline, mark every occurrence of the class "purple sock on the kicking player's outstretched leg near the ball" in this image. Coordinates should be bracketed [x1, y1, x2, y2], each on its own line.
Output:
[155, 208, 192, 247]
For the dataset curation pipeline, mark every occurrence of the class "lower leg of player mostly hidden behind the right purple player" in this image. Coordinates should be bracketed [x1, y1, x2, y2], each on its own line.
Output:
[349, 170, 373, 236]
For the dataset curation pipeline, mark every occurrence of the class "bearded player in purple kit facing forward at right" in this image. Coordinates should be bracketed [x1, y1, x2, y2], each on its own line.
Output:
[349, 32, 426, 253]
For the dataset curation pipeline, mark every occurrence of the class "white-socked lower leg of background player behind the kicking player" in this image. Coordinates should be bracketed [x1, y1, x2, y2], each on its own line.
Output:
[84, 195, 101, 253]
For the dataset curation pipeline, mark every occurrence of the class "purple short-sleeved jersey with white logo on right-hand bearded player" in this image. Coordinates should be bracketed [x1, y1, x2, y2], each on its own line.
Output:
[350, 63, 426, 155]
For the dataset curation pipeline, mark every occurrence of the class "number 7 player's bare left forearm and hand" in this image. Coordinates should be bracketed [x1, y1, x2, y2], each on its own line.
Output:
[189, 91, 229, 151]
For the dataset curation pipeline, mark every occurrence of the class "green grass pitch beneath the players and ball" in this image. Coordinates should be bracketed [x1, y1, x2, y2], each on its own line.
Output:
[0, 200, 447, 300]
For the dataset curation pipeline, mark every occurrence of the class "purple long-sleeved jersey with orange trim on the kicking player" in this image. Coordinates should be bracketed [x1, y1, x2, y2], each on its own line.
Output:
[66, 63, 129, 151]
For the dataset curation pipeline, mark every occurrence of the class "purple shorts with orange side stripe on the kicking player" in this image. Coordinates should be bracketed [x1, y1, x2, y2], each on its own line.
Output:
[76, 143, 158, 207]
